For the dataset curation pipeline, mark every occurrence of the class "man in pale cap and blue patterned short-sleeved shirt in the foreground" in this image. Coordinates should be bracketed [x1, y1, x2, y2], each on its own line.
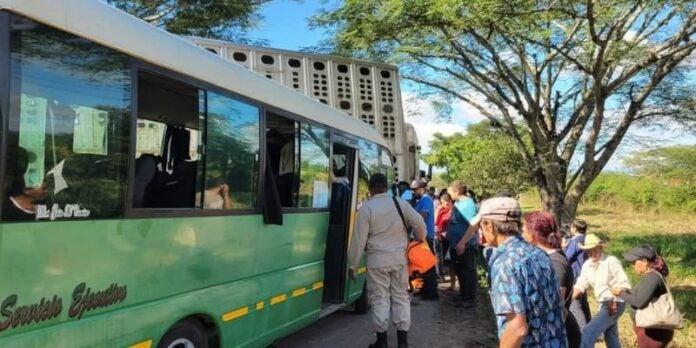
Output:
[472, 197, 568, 348]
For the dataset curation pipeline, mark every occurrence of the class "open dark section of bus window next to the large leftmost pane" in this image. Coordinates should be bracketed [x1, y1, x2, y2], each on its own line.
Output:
[133, 71, 205, 208]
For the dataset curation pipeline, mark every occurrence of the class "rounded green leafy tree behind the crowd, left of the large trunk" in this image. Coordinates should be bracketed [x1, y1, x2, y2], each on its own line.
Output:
[424, 121, 532, 197]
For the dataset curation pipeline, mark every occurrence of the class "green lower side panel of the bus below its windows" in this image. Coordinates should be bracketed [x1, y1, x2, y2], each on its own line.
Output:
[0, 212, 332, 347]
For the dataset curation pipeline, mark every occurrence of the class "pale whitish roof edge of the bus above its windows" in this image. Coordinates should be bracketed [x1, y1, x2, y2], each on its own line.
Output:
[0, 0, 387, 148]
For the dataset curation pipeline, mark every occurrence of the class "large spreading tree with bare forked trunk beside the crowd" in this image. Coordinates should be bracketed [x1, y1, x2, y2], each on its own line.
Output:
[314, 0, 696, 223]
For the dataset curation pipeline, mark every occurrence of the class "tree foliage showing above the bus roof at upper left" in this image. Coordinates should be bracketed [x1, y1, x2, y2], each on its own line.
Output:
[106, 0, 271, 42]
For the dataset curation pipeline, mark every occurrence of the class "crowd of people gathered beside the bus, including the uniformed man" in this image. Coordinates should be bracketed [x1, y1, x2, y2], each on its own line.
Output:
[349, 174, 674, 348]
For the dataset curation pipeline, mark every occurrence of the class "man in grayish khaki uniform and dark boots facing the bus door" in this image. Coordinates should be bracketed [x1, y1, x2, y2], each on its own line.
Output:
[348, 173, 425, 348]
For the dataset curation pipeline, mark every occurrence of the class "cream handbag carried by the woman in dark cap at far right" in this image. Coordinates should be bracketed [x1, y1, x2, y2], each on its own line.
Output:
[636, 272, 683, 330]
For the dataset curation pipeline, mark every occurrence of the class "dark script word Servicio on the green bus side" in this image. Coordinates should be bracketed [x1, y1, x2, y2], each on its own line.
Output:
[0, 295, 63, 332]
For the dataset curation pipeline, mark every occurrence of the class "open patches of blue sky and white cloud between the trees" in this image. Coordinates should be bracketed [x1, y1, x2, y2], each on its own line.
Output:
[251, 0, 696, 171]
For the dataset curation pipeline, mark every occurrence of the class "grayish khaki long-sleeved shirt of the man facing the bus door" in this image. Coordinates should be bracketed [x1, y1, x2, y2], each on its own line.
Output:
[348, 193, 425, 270]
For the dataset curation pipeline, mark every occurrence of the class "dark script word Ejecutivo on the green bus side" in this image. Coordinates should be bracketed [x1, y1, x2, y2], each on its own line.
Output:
[68, 282, 128, 320]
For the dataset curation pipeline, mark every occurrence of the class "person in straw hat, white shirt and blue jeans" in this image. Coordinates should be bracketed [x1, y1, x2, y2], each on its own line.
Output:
[573, 234, 631, 348]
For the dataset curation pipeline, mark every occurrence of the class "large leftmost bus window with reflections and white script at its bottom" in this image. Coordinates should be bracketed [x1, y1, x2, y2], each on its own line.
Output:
[2, 16, 131, 221]
